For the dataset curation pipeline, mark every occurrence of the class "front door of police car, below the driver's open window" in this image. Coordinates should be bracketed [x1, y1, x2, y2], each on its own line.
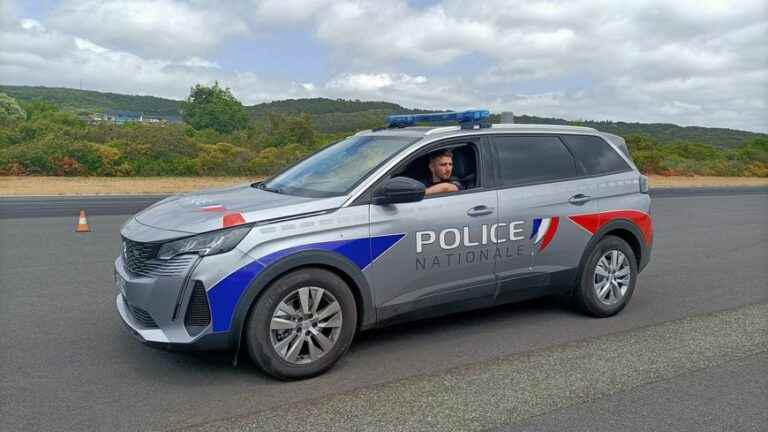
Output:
[364, 139, 497, 320]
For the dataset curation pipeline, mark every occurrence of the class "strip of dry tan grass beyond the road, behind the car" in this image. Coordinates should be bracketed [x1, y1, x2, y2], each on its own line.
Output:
[0, 176, 768, 196]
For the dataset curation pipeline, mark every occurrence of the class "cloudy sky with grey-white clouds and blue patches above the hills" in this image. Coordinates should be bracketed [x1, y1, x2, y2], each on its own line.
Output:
[0, 0, 768, 132]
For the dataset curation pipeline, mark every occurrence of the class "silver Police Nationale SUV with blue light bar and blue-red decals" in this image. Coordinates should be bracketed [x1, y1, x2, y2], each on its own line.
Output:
[115, 110, 653, 379]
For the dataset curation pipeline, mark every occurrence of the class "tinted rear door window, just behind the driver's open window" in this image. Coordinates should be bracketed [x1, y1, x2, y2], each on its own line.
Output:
[493, 136, 577, 186]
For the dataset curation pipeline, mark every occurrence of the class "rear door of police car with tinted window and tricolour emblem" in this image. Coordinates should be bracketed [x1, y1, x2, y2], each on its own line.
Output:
[492, 134, 595, 299]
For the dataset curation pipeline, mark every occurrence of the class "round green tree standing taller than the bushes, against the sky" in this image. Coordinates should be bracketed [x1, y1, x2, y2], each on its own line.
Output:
[181, 82, 248, 134]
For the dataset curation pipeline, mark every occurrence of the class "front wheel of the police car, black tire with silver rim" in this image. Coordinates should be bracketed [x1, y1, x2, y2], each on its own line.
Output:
[245, 268, 357, 380]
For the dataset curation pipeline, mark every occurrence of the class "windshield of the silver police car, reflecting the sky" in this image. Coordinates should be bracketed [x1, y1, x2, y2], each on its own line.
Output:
[263, 136, 416, 198]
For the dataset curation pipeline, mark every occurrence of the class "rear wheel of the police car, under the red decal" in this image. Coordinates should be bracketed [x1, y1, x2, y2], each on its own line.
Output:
[573, 236, 638, 318]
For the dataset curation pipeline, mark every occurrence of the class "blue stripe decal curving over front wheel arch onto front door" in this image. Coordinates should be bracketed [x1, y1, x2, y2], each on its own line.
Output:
[208, 234, 405, 332]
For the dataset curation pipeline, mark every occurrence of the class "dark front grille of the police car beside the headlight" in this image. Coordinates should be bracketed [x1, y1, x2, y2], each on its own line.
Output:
[122, 238, 196, 277]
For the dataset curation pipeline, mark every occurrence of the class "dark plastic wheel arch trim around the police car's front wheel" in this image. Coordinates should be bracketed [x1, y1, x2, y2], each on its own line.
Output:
[230, 250, 376, 351]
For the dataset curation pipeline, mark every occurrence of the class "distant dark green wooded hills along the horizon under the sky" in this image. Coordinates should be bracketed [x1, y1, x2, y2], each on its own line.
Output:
[0, 86, 768, 148]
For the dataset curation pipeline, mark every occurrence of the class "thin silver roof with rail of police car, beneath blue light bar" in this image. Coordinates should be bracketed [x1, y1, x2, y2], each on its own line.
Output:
[356, 123, 600, 138]
